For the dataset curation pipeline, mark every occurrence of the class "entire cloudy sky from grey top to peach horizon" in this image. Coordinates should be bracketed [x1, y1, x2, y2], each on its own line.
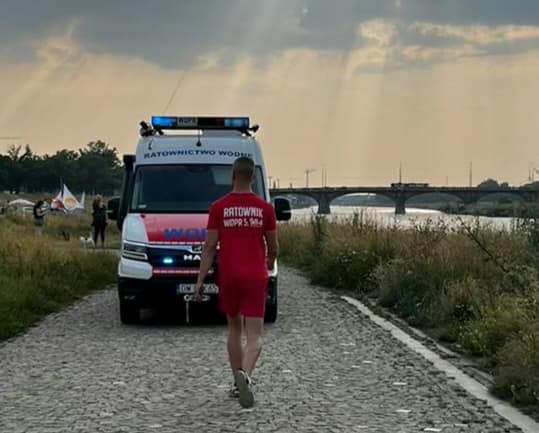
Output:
[0, 0, 539, 186]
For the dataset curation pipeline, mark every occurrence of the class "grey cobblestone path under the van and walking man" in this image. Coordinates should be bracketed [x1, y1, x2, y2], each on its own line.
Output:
[0, 268, 539, 433]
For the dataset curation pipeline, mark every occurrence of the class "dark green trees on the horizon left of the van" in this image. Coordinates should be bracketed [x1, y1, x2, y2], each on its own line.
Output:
[0, 140, 122, 195]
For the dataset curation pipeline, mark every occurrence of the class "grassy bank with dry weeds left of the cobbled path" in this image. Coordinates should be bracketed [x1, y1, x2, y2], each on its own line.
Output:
[0, 215, 118, 341]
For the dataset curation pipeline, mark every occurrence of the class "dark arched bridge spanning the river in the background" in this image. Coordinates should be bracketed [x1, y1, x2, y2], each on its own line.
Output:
[270, 184, 539, 215]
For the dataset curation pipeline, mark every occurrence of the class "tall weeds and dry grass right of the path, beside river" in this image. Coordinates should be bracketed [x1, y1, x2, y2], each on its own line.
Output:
[280, 214, 539, 406]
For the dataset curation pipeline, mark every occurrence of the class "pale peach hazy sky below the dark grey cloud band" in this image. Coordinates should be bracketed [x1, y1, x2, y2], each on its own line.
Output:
[0, 26, 539, 185]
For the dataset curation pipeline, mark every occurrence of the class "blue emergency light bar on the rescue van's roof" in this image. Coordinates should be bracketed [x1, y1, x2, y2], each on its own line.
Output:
[152, 116, 250, 130]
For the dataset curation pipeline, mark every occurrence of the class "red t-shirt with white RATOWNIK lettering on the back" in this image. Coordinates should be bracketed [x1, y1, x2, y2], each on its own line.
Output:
[208, 192, 276, 279]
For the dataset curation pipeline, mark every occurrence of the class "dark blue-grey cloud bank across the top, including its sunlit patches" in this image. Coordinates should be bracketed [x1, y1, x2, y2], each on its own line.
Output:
[0, 0, 539, 81]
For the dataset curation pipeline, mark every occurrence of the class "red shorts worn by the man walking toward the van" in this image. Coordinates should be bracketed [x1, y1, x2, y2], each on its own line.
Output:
[219, 275, 268, 317]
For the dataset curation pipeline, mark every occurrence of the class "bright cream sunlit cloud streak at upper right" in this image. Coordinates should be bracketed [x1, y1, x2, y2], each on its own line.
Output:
[349, 19, 539, 72]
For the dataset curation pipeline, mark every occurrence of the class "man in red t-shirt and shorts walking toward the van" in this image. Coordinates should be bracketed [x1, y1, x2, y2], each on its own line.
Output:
[195, 157, 278, 407]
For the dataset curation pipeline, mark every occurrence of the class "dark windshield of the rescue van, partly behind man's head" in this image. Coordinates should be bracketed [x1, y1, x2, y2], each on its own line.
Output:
[131, 164, 264, 213]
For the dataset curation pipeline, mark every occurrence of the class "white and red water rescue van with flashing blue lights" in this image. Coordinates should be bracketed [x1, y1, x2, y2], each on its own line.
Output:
[109, 116, 291, 324]
